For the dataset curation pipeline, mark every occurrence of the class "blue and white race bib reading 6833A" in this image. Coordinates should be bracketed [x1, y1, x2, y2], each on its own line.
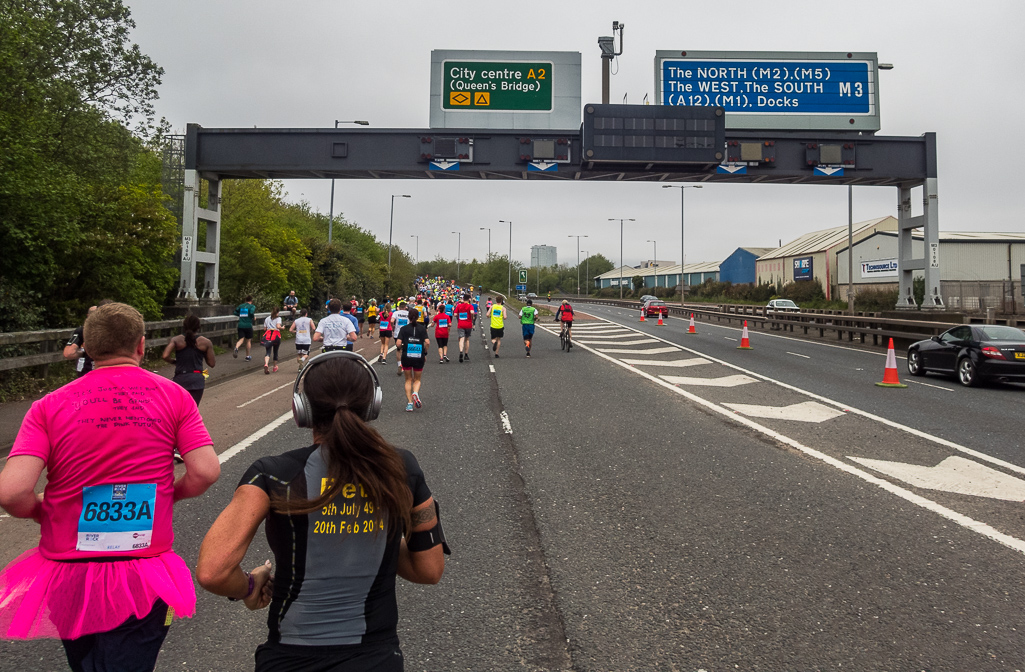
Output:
[75, 484, 157, 553]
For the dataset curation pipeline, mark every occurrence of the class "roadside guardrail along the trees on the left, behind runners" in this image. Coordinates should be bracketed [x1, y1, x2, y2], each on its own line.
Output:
[0, 312, 271, 378]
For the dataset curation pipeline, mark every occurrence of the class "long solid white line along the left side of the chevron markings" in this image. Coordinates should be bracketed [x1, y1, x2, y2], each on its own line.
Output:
[580, 333, 1025, 554]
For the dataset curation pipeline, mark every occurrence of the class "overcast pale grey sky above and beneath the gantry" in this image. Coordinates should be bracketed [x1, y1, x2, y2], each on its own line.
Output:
[126, 0, 1025, 265]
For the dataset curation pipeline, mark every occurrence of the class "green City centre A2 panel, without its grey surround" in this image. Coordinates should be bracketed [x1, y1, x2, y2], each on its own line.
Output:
[442, 60, 552, 112]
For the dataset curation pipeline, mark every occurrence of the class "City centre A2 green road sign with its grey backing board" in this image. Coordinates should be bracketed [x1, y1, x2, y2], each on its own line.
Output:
[431, 49, 580, 130]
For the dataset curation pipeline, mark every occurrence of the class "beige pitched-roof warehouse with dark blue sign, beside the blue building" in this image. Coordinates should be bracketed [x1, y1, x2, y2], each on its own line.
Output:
[755, 216, 897, 299]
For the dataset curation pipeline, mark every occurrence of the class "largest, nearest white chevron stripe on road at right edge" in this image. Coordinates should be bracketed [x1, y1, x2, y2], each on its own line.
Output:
[847, 455, 1025, 502]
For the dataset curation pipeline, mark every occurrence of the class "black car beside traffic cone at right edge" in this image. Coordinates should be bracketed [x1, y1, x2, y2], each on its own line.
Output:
[907, 325, 1025, 387]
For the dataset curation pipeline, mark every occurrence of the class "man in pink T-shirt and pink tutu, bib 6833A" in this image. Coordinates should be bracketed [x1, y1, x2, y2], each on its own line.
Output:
[0, 303, 220, 670]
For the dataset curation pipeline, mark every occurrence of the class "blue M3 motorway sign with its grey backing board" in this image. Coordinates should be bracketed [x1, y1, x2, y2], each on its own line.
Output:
[655, 50, 879, 131]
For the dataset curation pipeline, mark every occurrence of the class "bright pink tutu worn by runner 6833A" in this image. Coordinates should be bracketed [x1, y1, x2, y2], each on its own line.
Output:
[0, 548, 196, 639]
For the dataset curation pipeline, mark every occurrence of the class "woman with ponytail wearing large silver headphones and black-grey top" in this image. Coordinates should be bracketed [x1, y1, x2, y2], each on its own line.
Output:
[196, 350, 448, 672]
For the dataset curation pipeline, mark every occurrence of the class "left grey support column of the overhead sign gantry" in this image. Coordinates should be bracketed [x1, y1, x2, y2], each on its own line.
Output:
[175, 169, 220, 305]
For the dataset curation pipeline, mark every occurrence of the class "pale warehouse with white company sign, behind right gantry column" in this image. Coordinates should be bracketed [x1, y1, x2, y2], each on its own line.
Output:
[834, 230, 1025, 312]
